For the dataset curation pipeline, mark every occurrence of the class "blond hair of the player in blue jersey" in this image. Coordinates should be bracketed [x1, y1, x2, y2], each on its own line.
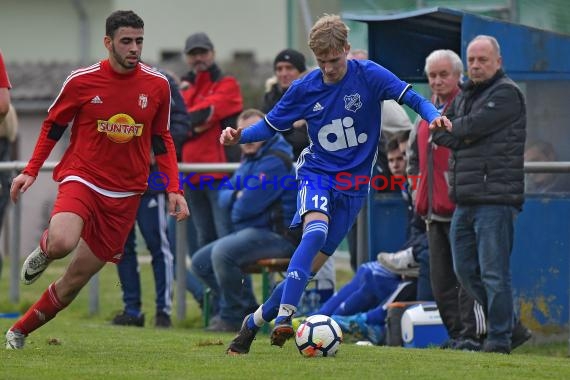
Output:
[309, 14, 350, 55]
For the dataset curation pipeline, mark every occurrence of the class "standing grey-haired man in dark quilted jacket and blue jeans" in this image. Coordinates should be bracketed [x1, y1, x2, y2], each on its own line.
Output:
[433, 35, 530, 353]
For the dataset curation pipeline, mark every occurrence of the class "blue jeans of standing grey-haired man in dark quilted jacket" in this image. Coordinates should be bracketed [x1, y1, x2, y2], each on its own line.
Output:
[450, 205, 518, 348]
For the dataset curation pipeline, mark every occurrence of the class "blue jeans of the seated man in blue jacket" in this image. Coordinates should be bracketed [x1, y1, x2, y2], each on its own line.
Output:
[192, 227, 295, 327]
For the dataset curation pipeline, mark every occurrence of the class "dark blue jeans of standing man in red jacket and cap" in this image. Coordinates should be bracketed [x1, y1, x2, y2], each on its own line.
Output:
[185, 180, 233, 248]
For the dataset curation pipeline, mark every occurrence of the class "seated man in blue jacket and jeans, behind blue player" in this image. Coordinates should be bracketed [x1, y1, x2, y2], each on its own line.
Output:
[191, 109, 300, 331]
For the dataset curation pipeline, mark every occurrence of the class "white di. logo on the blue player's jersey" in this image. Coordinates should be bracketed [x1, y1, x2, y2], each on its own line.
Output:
[318, 117, 368, 152]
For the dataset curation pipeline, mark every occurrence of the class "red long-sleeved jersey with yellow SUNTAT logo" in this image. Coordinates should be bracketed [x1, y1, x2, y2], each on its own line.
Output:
[24, 60, 179, 193]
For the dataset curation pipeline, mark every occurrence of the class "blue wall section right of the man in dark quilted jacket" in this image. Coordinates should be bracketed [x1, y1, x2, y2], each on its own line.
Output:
[511, 194, 570, 330]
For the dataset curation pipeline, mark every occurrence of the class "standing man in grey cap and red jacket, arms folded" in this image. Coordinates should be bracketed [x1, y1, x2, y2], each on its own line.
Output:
[181, 33, 243, 253]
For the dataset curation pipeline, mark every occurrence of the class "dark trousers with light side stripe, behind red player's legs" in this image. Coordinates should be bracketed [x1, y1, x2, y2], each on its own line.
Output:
[117, 194, 174, 315]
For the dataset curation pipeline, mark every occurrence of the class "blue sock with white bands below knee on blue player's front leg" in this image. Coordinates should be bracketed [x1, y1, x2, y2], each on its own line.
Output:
[276, 220, 328, 322]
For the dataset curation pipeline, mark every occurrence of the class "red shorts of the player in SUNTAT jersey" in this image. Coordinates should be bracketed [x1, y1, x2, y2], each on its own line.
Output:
[51, 181, 141, 263]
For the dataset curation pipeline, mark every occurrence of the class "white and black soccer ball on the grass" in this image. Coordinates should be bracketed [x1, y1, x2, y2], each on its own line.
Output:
[295, 314, 342, 357]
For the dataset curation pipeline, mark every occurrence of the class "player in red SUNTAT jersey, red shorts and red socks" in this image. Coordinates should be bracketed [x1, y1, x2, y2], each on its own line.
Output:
[6, 11, 189, 349]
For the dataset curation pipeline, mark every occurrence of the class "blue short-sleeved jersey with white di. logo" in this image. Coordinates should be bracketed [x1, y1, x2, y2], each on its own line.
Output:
[265, 60, 410, 194]
